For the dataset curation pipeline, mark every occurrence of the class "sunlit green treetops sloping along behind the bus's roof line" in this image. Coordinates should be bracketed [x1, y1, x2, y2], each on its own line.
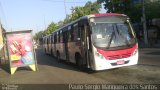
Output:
[35, 1, 101, 40]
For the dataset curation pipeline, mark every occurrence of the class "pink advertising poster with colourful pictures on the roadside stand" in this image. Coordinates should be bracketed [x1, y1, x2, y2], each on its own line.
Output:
[7, 33, 34, 67]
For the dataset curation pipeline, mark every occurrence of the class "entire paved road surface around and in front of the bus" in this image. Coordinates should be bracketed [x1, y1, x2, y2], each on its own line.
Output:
[0, 49, 160, 84]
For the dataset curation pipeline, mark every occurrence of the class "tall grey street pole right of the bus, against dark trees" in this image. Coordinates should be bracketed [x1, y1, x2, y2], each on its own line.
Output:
[142, 0, 148, 47]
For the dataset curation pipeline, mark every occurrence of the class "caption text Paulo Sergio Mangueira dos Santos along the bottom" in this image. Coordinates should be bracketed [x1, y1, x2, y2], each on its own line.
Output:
[69, 84, 160, 90]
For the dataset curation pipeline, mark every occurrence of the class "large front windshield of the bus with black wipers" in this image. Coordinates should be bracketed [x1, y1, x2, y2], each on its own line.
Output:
[91, 17, 136, 50]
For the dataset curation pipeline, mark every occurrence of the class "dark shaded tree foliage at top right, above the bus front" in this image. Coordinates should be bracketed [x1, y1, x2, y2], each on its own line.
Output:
[97, 0, 160, 22]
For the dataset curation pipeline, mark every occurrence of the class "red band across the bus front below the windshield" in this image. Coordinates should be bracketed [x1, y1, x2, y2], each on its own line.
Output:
[97, 45, 138, 60]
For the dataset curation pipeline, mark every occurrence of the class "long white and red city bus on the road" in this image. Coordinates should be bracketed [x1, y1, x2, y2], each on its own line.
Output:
[45, 13, 138, 70]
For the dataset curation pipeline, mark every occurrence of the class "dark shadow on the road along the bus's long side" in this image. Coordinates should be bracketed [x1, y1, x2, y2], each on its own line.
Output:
[36, 49, 92, 73]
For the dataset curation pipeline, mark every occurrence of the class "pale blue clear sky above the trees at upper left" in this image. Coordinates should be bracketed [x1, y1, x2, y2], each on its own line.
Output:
[0, 0, 105, 33]
